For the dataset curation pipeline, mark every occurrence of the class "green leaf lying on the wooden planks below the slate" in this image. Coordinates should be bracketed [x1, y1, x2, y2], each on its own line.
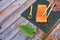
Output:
[18, 25, 36, 37]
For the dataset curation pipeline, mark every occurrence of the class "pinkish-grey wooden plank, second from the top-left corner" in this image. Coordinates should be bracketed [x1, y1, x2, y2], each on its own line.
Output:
[0, 0, 27, 22]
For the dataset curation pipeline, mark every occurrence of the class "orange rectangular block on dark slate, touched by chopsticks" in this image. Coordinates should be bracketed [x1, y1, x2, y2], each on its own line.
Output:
[36, 5, 47, 22]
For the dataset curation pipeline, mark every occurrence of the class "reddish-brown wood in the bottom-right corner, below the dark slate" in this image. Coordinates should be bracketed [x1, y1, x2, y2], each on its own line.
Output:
[45, 20, 60, 40]
